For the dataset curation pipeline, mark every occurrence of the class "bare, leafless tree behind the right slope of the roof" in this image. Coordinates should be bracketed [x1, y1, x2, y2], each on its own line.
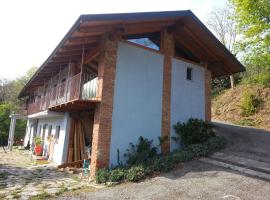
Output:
[206, 2, 237, 91]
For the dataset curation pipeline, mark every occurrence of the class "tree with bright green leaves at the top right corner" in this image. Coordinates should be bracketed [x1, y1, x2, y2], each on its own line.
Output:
[230, 0, 270, 83]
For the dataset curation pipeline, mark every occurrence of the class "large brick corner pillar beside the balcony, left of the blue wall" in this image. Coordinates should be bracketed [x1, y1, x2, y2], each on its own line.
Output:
[90, 37, 117, 178]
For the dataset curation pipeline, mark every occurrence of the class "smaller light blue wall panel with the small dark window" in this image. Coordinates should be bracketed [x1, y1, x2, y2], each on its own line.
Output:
[171, 59, 205, 150]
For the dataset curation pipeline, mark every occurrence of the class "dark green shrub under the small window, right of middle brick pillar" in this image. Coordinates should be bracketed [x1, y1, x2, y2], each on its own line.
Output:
[173, 118, 215, 146]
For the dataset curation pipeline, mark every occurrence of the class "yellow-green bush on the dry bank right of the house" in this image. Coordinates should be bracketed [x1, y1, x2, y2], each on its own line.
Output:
[241, 90, 259, 117]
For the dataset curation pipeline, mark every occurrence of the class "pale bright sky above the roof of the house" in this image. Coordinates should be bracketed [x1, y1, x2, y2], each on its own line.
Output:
[0, 0, 225, 79]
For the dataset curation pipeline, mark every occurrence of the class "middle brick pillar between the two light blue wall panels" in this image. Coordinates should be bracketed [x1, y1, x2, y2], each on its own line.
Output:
[161, 30, 175, 154]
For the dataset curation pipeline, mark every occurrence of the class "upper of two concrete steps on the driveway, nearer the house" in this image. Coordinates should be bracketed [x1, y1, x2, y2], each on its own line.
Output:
[210, 152, 270, 175]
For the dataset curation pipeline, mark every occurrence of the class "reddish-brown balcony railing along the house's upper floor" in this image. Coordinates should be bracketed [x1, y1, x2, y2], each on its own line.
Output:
[27, 73, 98, 115]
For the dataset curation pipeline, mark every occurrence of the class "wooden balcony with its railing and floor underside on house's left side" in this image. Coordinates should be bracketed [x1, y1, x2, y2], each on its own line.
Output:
[27, 73, 99, 115]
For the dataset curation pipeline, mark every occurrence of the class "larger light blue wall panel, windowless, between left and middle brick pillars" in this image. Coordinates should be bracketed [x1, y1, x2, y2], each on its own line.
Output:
[110, 42, 163, 166]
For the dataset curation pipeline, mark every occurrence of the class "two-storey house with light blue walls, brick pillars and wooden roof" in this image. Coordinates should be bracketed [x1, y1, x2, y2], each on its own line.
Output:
[19, 10, 244, 177]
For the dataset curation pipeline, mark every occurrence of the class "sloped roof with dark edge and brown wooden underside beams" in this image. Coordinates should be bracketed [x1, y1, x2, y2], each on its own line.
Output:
[19, 10, 245, 97]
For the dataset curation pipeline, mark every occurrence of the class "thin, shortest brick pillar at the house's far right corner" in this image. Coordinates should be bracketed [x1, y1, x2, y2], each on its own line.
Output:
[205, 68, 212, 121]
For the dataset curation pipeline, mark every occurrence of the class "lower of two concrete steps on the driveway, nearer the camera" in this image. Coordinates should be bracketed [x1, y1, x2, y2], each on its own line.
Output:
[200, 158, 270, 181]
